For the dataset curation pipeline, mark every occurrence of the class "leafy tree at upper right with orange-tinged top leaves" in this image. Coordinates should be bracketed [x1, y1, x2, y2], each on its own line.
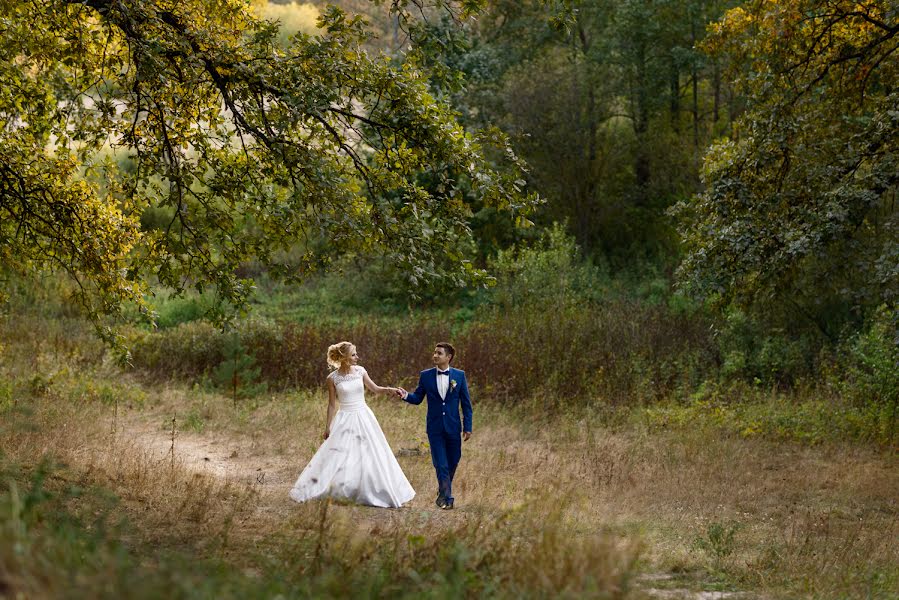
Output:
[674, 0, 899, 338]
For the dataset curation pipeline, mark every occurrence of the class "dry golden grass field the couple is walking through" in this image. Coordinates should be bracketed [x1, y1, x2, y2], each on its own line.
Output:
[0, 312, 899, 599]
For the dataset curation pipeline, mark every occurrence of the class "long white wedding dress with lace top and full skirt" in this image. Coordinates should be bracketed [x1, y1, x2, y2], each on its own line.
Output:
[290, 366, 415, 508]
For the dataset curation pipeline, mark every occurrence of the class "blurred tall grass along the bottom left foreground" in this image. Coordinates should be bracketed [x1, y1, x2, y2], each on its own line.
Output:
[0, 382, 639, 599]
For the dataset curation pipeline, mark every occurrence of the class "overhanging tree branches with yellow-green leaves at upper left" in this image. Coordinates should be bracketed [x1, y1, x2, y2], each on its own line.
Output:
[0, 0, 532, 338]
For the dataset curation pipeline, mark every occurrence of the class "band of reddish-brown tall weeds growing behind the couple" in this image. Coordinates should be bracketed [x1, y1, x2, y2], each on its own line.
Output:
[126, 301, 715, 405]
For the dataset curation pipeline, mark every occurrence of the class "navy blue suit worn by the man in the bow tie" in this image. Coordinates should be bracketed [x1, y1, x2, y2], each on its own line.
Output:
[404, 367, 471, 502]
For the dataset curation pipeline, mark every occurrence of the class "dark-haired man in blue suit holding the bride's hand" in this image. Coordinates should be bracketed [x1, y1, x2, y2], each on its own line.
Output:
[397, 342, 471, 510]
